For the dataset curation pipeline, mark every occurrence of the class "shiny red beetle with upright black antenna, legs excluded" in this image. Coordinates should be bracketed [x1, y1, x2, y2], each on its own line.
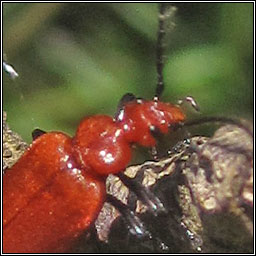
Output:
[3, 3, 188, 253]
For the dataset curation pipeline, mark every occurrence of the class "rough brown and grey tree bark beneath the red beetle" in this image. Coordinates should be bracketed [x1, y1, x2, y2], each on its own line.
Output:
[3, 113, 253, 253]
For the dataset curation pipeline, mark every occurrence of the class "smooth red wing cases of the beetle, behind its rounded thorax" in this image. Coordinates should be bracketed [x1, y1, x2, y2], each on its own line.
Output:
[3, 133, 106, 253]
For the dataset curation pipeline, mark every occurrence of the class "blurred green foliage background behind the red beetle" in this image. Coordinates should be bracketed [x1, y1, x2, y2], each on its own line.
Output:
[3, 3, 253, 142]
